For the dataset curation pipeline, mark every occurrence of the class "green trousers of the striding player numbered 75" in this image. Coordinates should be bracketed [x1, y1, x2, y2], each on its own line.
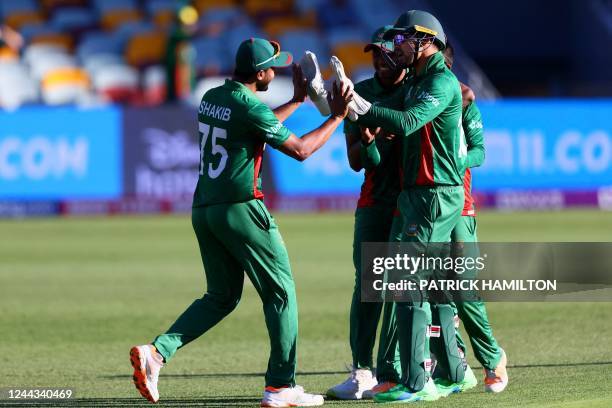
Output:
[153, 200, 298, 387]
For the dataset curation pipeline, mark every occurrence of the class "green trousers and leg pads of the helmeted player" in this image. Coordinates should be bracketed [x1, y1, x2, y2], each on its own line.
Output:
[397, 186, 465, 392]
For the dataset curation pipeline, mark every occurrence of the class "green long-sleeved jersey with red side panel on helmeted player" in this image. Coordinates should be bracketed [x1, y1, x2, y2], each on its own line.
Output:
[358, 52, 467, 189]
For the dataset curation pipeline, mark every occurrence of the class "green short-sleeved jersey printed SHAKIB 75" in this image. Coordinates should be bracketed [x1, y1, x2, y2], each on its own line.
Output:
[193, 79, 291, 207]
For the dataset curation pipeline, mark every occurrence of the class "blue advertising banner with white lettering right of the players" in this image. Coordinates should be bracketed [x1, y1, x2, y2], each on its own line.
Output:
[474, 100, 612, 191]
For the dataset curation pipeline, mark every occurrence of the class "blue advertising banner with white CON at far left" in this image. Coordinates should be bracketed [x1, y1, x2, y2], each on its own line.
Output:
[0, 107, 123, 200]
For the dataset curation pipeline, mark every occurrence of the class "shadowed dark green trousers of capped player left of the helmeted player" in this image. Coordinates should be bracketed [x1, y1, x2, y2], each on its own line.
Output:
[349, 206, 402, 382]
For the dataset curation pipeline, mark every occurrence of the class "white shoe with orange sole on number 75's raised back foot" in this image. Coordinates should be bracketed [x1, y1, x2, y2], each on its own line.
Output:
[130, 344, 164, 403]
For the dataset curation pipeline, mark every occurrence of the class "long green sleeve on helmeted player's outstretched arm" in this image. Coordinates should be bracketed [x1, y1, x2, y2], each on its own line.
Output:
[357, 75, 458, 136]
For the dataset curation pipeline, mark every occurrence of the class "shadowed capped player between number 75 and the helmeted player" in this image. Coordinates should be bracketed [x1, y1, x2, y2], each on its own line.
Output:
[327, 25, 408, 400]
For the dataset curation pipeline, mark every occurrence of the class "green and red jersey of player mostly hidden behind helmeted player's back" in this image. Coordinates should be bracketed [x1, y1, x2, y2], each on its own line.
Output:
[461, 102, 485, 216]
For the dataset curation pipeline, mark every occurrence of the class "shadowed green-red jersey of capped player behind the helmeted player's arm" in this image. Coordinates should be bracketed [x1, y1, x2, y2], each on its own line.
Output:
[344, 75, 408, 208]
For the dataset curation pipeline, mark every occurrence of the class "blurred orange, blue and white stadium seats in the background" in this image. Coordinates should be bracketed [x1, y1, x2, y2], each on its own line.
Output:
[0, 0, 420, 107]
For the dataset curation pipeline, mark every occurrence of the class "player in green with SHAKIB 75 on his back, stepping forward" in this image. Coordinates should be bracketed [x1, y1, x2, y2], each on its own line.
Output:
[130, 38, 352, 407]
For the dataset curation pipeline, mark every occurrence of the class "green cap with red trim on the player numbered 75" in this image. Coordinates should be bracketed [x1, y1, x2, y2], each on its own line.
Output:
[236, 38, 293, 75]
